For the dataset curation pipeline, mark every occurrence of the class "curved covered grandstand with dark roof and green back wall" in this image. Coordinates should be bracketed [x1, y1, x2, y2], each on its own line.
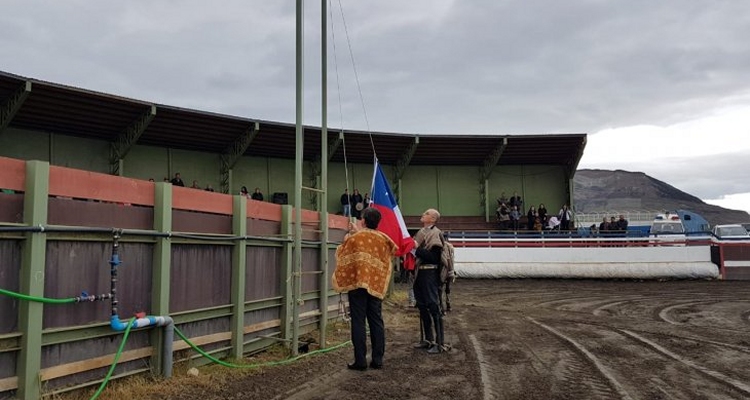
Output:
[0, 72, 586, 224]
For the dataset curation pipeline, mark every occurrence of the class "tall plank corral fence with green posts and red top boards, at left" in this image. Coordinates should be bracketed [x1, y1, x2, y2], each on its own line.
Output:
[0, 157, 348, 399]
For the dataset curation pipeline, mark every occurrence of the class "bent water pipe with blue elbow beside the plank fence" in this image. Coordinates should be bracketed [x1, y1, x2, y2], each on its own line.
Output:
[109, 231, 174, 378]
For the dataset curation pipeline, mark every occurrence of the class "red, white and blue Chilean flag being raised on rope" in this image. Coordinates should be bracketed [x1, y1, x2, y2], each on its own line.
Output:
[370, 158, 414, 257]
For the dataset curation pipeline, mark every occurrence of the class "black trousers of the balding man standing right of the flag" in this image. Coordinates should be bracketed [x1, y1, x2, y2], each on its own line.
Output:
[414, 269, 443, 345]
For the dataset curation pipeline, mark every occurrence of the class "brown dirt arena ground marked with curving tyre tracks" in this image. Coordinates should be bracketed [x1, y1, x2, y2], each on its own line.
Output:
[92, 280, 750, 400]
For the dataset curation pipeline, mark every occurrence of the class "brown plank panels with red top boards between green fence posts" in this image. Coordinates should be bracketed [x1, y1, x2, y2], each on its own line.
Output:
[0, 157, 348, 398]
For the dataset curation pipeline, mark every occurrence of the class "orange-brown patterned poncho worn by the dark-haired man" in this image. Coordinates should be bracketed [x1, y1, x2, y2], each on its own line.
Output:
[332, 229, 398, 299]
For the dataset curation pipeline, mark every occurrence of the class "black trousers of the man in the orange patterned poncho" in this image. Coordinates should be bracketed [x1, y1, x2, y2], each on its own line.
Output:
[349, 289, 385, 366]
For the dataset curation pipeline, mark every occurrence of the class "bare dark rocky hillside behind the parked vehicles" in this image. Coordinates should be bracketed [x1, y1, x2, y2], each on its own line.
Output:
[574, 169, 750, 226]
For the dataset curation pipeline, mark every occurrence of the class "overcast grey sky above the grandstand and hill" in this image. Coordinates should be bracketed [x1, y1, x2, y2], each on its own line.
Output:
[0, 0, 750, 216]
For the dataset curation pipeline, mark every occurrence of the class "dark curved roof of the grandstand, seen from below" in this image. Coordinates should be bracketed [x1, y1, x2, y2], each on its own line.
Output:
[0, 71, 586, 168]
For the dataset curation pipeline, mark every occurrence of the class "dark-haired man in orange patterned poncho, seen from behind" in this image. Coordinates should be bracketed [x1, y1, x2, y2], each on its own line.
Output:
[332, 208, 398, 371]
